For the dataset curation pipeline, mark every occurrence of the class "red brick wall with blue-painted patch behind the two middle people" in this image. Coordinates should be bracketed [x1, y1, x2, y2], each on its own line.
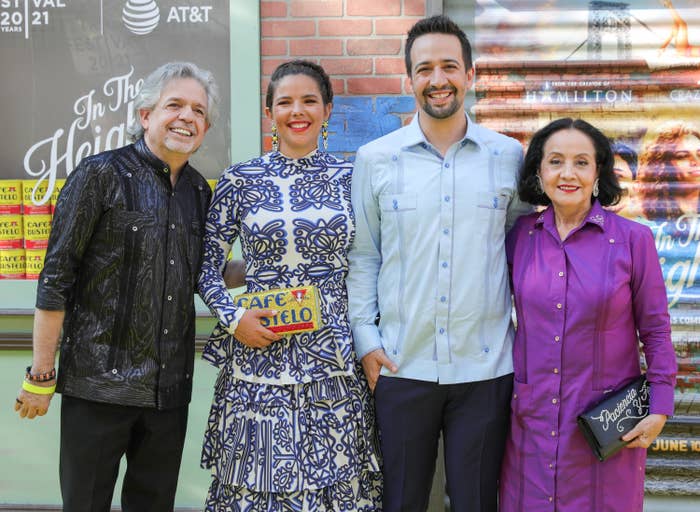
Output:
[260, 0, 427, 157]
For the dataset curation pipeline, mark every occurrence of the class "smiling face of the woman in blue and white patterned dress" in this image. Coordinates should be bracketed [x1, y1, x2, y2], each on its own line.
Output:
[265, 74, 331, 158]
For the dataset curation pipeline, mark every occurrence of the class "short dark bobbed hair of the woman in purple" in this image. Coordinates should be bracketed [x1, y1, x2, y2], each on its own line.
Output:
[518, 117, 622, 206]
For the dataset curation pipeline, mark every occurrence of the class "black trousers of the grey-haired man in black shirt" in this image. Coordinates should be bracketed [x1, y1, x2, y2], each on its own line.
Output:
[59, 396, 187, 512]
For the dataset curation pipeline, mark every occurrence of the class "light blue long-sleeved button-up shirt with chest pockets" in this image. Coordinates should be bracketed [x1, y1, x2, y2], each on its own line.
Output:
[347, 114, 531, 384]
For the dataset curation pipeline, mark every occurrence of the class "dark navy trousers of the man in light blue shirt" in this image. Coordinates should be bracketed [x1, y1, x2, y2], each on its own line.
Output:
[374, 374, 513, 512]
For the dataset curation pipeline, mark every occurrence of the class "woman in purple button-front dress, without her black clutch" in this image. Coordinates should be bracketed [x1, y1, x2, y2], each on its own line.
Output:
[500, 119, 676, 512]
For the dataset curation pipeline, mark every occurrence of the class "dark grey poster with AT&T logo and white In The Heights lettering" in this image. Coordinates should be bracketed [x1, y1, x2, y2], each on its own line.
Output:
[0, 0, 230, 190]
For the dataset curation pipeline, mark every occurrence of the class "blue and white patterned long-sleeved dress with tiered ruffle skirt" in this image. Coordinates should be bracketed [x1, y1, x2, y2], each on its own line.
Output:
[199, 151, 381, 512]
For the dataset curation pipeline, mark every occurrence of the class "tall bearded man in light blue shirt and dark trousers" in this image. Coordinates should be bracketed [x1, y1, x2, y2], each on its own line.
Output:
[347, 16, 531, 512]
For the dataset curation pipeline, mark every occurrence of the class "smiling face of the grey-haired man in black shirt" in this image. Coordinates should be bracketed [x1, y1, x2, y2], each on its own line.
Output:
[139, 78, 209, 171]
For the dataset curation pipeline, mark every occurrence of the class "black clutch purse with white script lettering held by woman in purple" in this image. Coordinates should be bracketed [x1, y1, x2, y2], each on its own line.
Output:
[576, 375, 649, 461]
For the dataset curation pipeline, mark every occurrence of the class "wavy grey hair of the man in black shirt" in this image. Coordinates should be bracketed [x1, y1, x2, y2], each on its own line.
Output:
[126, 62, 219, 140]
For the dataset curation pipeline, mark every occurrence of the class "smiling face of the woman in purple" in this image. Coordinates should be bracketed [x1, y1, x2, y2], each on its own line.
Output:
[539, 128, 598, 213]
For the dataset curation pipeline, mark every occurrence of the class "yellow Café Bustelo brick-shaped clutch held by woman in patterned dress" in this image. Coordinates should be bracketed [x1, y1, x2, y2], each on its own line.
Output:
[233, 286, 321, 334]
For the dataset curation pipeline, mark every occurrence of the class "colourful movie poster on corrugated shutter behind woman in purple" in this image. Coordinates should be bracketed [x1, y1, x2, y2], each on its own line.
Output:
[473, 0, 700, 389]
